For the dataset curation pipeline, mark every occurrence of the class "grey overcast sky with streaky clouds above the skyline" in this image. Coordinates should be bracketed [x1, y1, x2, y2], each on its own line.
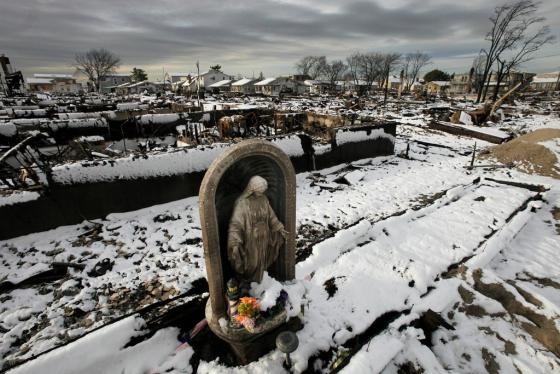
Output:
[0, 0, 560, 79]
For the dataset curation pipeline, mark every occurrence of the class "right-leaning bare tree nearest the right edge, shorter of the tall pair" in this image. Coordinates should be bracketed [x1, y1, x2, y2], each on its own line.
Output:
[492, 23, 555, 101]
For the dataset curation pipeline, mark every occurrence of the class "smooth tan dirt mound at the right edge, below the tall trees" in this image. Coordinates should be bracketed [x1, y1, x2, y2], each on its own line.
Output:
[480, 129, 560, 179]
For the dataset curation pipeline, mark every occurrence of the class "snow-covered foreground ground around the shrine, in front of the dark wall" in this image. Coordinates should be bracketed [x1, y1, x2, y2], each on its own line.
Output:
[0, 114, 560, 373]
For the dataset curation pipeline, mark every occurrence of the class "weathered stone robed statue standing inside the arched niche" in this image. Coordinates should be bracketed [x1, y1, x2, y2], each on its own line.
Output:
[228, 175, 287, 283]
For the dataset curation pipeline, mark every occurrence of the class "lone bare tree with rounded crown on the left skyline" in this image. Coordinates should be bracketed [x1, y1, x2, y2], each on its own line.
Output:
[74, 48, 121, 91]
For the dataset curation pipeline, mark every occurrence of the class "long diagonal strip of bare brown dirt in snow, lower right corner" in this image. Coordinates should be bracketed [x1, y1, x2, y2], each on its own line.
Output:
[473, 269, 560, 361]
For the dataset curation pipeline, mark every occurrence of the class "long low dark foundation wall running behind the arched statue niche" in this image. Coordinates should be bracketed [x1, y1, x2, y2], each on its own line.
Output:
[0, 123, 396, 239]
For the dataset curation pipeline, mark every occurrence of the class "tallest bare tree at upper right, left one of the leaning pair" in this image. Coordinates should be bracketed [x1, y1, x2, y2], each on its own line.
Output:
[477, 0, 542, 102]
